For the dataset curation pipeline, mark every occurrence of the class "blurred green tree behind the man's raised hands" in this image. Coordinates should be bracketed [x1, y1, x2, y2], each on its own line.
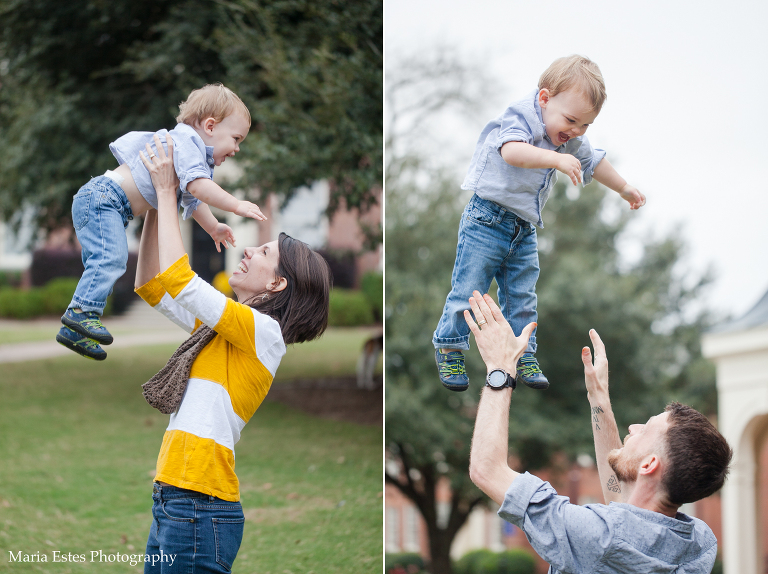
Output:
[385, 166, 715, 574]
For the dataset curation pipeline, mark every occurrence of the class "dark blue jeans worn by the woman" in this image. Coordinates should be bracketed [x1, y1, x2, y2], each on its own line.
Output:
[144, 483, 245, 574]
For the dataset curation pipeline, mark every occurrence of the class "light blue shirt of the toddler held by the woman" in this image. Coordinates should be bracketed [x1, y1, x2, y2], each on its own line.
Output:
[109, 124, 215, 219]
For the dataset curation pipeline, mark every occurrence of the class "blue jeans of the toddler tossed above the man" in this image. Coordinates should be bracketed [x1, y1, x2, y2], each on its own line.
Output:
[432, 195, 539, 353]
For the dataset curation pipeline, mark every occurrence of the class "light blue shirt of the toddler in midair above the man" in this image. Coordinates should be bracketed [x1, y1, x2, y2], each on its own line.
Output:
[461, 90, 605, 227]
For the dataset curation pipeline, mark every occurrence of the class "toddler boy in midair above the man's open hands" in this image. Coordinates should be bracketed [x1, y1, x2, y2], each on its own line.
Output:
[432, 56, 645, 391]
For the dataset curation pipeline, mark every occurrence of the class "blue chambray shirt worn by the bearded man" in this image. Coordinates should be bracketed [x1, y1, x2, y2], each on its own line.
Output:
[499, 473, 717, 574]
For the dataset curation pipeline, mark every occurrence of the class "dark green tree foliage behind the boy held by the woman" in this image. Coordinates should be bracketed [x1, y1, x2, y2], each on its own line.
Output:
[0, 0, 383, 235]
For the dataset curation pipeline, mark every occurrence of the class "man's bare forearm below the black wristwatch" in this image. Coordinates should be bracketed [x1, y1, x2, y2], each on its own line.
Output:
[469, 390, 519, 505]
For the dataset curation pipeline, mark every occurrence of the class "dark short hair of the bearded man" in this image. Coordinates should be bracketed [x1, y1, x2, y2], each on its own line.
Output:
[662, 403, 733, 506]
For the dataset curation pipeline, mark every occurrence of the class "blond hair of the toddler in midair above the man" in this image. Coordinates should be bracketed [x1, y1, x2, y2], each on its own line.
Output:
[539, 54, 606, 112]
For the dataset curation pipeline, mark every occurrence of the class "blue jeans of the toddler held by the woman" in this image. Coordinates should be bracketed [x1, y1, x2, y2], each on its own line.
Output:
[68, 175, 133, 315]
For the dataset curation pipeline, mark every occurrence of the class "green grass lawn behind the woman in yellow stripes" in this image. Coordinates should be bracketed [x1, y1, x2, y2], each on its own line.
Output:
[0, 345, 383, 574]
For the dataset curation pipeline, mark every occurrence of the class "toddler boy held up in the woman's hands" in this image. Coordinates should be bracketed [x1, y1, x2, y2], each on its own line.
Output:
[56, 84, 266, 360]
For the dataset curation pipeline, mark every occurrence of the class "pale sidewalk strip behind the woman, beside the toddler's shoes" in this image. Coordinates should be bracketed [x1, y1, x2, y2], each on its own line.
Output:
[0, 301, 189, 363]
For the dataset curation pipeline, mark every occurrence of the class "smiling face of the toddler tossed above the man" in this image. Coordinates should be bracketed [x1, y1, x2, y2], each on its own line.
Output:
[538, 88, 599, 147]
